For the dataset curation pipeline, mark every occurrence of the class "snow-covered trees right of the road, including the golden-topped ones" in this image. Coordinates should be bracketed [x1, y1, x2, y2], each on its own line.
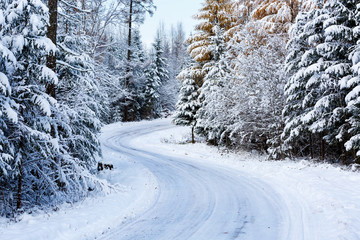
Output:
[175, 0, 360, 164]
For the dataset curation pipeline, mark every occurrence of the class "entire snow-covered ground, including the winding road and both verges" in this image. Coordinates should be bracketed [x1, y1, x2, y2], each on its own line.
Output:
[0, 120, 360, 240]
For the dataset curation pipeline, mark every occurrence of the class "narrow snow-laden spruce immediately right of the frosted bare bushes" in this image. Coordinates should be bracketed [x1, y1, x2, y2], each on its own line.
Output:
[282, 9, 326, 157]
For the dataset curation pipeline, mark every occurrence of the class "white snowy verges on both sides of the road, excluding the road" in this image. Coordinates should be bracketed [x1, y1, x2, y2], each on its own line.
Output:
[0, 119, 360, 240]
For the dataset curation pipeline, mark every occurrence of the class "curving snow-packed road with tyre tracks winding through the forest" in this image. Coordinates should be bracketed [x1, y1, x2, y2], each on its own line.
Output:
[99, 121, 300, 240]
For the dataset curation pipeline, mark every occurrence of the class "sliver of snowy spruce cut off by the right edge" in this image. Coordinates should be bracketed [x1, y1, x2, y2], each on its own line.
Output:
[342, 1, 360, 163]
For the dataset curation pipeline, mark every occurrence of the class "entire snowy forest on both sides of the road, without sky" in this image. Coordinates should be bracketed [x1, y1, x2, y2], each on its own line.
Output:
[0, 0, 360, 217]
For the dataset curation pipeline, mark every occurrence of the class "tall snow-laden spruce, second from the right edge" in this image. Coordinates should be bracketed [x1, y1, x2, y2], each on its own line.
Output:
[303, 0, 356, 160]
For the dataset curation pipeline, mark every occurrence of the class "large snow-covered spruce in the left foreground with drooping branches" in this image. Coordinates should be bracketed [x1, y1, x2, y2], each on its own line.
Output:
[1, 0, 107, 216]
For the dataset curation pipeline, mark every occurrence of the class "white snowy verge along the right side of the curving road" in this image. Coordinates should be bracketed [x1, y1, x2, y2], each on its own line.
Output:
[132, 119, 360, 240]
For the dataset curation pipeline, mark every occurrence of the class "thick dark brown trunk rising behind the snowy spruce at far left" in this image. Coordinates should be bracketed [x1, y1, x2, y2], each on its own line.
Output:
[46, 0, 58, 98]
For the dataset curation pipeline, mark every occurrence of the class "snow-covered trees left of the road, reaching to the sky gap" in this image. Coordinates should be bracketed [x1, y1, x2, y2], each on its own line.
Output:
[0, 0, 186, 217]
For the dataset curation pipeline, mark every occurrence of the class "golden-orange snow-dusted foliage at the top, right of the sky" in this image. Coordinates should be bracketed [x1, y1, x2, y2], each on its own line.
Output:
[187, 0, 320, 85]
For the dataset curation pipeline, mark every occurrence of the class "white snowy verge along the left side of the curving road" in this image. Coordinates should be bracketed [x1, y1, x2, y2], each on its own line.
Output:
[0, 124, 157, 240]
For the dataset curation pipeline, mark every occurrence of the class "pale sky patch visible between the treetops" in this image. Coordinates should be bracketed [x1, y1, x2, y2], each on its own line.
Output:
[140, 0, 204, 47]
